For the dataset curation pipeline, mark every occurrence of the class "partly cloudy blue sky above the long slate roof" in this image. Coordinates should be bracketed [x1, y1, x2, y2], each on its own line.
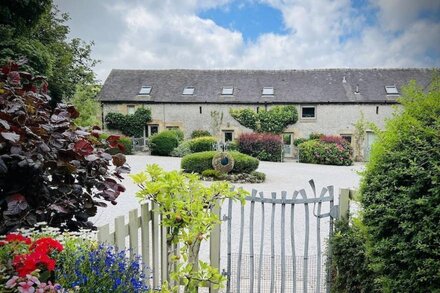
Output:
[54, 0, 440, 82]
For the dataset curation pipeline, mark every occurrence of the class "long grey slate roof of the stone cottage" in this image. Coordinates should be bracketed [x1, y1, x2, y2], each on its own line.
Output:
[98, 69, 432, 104]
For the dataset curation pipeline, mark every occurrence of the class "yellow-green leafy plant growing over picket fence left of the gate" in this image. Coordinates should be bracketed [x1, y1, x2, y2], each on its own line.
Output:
[131, 165, 247, 292]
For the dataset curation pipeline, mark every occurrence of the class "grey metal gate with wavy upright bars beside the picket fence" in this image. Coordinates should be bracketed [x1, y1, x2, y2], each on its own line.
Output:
[224, 180, 337, 292]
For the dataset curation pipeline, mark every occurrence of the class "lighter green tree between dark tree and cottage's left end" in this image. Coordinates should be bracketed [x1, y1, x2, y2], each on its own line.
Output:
[70, 84, 101, 127]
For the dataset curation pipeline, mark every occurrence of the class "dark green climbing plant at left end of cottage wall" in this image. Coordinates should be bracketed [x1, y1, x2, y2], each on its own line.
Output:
[105, 108, 151, 137]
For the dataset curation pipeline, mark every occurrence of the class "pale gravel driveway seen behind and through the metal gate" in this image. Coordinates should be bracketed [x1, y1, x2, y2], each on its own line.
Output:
[92, 156, 363, 288]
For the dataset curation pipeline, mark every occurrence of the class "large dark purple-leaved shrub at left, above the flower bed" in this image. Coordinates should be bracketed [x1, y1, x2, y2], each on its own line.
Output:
[0, 63, 128, 234]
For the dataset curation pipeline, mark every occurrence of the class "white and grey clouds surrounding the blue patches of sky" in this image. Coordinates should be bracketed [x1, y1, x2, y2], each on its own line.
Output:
[84, 0, 440, 80]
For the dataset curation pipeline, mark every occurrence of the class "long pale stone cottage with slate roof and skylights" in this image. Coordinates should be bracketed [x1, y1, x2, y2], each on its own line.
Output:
[98, 69, 432, 156]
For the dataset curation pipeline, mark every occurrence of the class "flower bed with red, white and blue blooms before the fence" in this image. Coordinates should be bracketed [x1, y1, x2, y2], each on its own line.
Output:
[0, 228, 148, 292]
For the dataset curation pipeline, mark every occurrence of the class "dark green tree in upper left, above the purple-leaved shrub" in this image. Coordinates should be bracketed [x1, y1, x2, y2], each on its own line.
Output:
[0, 0, 97, 106]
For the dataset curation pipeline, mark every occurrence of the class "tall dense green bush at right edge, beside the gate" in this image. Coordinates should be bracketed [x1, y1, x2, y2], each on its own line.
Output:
[360, 75, 440, 292]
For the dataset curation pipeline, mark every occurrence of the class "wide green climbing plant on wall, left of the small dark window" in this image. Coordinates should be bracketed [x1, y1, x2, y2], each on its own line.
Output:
[229, 106, 298, 134]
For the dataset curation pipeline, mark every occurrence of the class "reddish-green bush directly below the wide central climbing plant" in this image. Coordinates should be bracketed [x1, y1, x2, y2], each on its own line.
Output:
[236, 133, 283, 162]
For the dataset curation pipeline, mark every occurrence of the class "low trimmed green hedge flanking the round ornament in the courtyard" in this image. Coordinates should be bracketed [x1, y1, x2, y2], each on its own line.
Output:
[181, 151, 260, 174]
